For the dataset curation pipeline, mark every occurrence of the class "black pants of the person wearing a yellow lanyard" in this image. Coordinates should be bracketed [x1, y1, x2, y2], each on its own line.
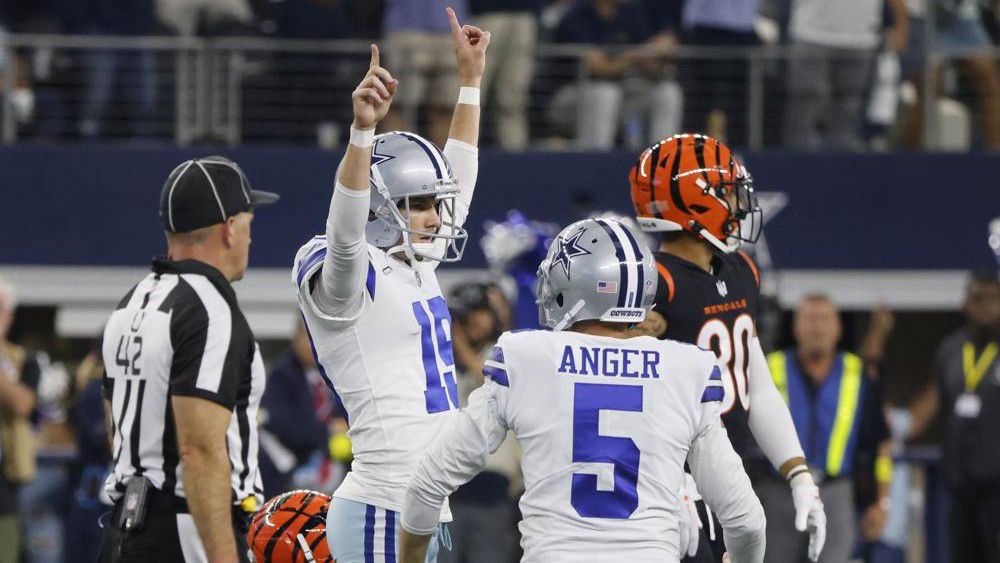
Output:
[948, 489, 1000, 563]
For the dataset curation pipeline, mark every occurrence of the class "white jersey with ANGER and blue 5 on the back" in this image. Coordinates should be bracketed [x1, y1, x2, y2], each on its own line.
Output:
[402, 331, 763, 563]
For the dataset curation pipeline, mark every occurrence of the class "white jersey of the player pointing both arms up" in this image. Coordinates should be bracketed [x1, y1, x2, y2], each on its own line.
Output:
[292, 236, 459, 521]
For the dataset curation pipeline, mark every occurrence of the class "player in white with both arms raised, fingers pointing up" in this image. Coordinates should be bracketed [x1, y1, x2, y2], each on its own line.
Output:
[292, 8, 490, 563]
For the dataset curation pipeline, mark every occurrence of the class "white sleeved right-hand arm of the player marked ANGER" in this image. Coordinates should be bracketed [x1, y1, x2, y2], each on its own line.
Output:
[688, 388, 765, 563]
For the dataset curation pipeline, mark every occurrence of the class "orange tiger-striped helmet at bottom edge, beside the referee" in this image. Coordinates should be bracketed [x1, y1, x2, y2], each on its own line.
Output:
[247, 491, 334, 563]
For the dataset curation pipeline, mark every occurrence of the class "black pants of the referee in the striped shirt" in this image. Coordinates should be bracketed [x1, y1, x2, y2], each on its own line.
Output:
[98, 489, 250, 563]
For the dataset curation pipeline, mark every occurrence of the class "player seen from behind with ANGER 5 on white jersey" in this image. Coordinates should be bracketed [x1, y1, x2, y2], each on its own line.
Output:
[400, 219, 765, 563]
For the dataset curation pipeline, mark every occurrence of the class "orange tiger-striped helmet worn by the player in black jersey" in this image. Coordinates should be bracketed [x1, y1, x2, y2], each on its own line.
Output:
[629, 134, 761, 252]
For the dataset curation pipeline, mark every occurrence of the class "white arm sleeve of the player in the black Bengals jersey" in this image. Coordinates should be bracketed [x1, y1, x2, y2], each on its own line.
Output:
[747, 336, 805, 468]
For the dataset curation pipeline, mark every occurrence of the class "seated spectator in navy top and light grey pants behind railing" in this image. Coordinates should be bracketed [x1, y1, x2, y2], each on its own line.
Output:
[549, 0, 683, 149]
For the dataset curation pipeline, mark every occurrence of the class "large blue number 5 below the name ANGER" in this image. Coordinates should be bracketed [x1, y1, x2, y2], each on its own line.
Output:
[570, 383, 642, 520]
